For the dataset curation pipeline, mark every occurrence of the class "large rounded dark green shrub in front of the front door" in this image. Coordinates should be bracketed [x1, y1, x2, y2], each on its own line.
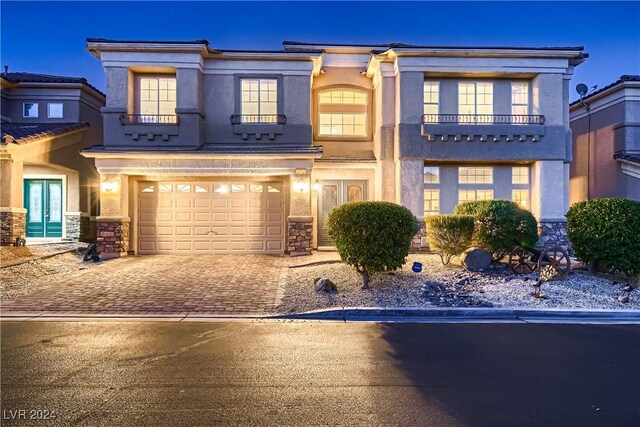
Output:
[327, 202, 420, 289]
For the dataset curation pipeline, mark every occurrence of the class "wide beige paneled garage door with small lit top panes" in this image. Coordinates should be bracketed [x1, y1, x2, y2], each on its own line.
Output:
[138, 182, 284, 254]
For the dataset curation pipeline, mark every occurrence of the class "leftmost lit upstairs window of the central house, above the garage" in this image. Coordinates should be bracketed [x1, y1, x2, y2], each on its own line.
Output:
[138, 76, 177, 123]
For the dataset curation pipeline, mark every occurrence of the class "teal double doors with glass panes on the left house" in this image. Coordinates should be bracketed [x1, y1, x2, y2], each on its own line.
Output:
[24, 179, 62, 237]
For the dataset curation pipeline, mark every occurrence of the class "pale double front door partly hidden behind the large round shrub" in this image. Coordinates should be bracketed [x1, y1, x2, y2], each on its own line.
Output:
[318, 181, 367, 246]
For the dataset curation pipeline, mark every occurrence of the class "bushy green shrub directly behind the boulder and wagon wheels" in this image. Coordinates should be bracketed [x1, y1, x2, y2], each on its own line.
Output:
[455, 200, 538, 261]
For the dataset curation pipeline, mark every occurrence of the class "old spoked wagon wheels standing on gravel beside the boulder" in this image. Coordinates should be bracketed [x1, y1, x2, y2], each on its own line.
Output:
[509, 239, 571, 282]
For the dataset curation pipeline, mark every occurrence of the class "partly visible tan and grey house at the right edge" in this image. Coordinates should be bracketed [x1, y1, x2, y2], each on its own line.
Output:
[570, 75, 640, 203]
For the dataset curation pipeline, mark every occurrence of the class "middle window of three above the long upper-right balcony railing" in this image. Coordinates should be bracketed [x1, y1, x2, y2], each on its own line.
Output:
[458, 82, 493, 124]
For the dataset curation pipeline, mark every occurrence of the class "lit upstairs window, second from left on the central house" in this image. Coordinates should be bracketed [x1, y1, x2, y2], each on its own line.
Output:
[240, 79, 278, 123]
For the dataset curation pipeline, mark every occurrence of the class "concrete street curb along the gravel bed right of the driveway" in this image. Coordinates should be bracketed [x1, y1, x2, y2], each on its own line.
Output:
[274, 307, 640, 324]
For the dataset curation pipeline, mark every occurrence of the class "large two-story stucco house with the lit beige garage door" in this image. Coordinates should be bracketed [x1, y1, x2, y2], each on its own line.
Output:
[83, 39, 587, 256]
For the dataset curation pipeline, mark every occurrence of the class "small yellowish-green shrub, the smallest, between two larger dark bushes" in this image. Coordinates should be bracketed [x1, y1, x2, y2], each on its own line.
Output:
[425, 215, 474, 265]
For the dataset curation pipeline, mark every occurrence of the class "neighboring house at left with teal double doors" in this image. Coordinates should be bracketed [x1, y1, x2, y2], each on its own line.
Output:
[0, 67, 105, 245]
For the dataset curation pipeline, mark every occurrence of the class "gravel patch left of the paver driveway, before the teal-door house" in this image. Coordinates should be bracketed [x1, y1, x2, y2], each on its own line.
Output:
[0, 243, 102, 301]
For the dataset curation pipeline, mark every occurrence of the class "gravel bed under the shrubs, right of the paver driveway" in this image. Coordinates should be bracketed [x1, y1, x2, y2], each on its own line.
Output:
[278, 254, 640, 313]
